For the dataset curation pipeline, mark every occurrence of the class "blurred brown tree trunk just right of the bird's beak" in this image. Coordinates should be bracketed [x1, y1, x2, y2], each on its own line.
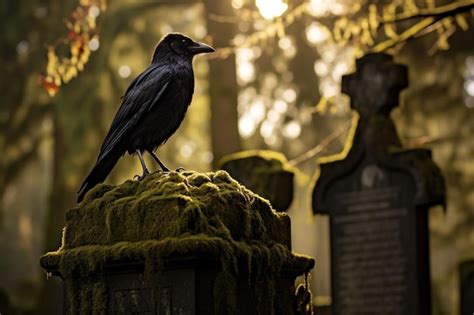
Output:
[204, 0, 241, 167]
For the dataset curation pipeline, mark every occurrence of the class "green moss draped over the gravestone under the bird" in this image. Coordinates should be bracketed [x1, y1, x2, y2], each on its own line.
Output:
[41, 171, 314, 313]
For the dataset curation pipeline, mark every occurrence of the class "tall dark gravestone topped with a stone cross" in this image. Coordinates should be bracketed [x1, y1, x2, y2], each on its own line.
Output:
[313, 54, 445, 315]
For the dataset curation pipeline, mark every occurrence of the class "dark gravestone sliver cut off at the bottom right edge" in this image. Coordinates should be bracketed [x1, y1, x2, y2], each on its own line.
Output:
[459, 259, 474, 315]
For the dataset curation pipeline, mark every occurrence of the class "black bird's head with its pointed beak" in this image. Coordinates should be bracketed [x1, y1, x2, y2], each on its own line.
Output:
[152, 33, 214, 61]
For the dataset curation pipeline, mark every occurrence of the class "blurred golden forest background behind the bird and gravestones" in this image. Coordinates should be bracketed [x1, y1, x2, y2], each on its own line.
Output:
[0, 0, 474, 314]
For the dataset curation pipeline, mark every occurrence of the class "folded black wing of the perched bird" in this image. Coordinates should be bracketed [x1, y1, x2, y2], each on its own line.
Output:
[97, 65, 171, 161]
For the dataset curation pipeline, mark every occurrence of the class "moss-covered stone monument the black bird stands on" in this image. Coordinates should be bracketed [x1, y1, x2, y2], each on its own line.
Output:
[41, 171, 314, 314]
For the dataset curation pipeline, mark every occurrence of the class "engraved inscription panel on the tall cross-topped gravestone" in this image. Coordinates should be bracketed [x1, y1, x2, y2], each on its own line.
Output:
[332, 181, 408, 314]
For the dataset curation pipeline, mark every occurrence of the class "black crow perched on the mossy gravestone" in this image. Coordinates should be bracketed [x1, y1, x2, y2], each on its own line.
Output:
[77, 33, 214, 202]
